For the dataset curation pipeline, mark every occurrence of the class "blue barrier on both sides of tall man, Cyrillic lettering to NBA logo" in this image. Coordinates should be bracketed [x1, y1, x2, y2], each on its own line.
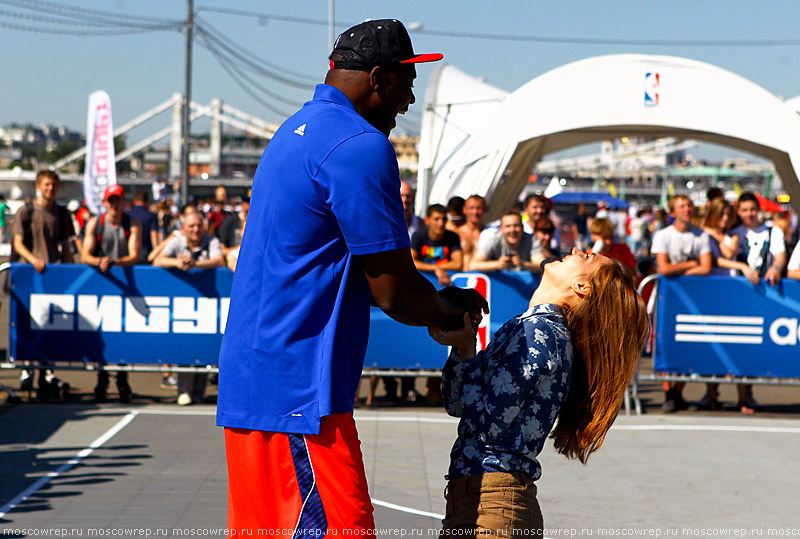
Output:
[9, 264, 539, 369]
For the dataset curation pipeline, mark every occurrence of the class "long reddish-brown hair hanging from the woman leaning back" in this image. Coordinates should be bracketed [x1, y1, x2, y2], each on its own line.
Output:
[550, 260, 648, 463]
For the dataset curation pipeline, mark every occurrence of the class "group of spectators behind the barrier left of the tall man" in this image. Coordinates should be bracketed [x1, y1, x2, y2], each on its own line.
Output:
[6, 175, 249, 405]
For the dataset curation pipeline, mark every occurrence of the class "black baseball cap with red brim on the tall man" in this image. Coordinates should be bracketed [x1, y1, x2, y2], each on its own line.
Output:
[328, 19, 444, 69]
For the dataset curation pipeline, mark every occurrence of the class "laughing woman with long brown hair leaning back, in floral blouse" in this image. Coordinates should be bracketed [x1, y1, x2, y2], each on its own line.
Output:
[429, 249, 648, 537]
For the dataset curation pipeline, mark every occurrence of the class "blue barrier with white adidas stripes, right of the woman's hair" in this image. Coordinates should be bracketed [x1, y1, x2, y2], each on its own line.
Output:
[653, 276, 800, 378]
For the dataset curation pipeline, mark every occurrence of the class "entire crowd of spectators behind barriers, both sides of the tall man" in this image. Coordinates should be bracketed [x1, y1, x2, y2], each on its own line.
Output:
[6, 171, 800, 413]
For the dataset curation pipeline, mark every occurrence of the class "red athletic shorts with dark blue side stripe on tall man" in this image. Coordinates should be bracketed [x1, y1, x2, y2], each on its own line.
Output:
[225, 413, 375, 538]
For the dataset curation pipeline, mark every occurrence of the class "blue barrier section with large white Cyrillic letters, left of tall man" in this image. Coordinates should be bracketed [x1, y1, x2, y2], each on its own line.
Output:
[9, 264, 233, 365]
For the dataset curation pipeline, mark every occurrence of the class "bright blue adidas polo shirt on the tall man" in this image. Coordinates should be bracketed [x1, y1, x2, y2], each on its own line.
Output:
[217, 84, 409, 434]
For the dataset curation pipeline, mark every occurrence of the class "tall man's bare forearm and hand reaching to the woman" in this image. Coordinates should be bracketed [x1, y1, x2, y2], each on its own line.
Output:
[356, 249, 489, 330]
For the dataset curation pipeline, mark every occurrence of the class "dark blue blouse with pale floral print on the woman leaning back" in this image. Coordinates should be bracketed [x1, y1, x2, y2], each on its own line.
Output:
[442, 304, 572, 480]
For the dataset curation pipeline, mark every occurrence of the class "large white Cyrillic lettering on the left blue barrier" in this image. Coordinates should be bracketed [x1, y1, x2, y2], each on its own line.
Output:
[29, 294, 230, 335]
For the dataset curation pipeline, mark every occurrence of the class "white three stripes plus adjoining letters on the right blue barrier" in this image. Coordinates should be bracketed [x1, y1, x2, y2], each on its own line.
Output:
[675, 314, 800, 346]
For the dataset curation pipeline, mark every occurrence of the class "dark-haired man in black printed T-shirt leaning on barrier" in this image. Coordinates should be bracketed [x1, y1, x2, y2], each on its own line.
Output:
[411, 204, 463, 286]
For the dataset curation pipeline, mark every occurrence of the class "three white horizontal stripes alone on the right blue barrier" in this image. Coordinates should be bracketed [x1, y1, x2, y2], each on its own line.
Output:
[675, 314, 764, 344]
